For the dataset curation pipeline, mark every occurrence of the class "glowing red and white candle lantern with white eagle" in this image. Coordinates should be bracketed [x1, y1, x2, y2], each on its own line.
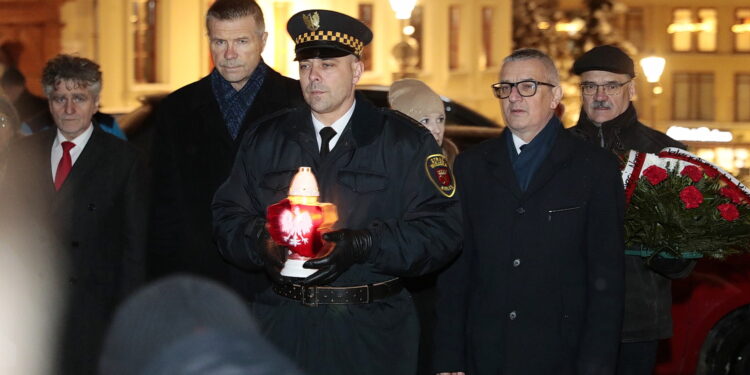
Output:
[266, 167, 338, 277]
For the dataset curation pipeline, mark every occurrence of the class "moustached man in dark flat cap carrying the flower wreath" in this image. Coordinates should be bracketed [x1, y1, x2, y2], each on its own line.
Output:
[571, 46, 694, 375]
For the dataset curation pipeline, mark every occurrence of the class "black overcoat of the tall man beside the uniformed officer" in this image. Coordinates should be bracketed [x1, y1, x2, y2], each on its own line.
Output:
[149, 68, 304, 297]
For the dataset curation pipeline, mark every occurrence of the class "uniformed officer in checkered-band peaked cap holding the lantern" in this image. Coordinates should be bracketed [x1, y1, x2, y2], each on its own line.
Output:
[213, 10, 461, 375]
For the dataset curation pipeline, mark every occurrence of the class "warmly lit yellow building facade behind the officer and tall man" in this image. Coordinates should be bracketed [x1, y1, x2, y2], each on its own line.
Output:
[45, 0, 512, 121]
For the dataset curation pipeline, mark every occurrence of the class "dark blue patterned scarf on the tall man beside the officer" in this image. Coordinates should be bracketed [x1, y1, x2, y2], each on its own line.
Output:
[211, 60, 268, 139]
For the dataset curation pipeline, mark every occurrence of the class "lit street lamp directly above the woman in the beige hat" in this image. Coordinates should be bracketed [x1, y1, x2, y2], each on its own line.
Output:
[390, 0, 419, 81]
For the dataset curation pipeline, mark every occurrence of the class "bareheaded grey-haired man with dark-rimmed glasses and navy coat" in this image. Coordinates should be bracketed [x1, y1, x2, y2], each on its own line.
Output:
[433, 49, 624, 375]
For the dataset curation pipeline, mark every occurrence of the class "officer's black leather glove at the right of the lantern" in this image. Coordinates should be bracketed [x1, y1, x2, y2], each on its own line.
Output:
[301, 229, 372, 285]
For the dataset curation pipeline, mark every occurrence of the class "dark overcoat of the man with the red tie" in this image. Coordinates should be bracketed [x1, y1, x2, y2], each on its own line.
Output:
[0, 126, 148, 374]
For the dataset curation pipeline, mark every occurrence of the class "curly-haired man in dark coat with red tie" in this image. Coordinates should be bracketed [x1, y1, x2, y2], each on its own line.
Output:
[0, 55, 148, 374]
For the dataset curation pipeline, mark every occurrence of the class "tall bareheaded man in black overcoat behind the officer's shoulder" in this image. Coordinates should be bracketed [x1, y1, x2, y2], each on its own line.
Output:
[149, 0, 304, 298]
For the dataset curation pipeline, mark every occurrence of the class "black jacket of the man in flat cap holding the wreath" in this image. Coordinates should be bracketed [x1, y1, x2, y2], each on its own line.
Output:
[570, 104, 695, 342]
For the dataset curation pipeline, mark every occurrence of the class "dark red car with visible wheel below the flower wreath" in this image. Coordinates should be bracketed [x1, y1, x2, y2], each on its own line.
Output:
[655, 255, 750, 375]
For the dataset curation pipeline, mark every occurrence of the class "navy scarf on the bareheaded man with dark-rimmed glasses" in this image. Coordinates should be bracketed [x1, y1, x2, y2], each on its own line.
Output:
[505, 116, 563, 191]
